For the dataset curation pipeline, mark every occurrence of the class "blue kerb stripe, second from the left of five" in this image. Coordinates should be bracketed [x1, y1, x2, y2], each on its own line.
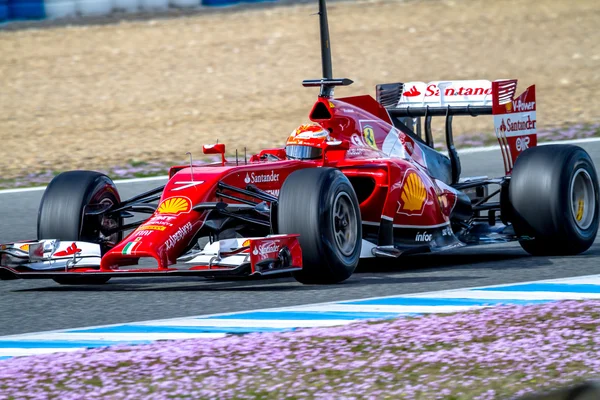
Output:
[67, 325, 291, 333]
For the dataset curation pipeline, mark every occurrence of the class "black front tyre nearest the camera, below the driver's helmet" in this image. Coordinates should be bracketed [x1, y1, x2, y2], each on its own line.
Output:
[277, 168, 362, 284]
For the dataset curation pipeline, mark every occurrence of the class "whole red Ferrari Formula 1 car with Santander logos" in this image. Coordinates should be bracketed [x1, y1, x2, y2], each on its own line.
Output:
[0, 0, 599, 284]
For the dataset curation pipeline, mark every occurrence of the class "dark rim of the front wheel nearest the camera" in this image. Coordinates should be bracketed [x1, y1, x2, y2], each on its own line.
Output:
[332, 192, 356, 256]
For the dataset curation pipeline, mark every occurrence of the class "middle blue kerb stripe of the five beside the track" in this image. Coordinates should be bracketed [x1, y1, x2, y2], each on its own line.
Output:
[204, 311, 418, 321]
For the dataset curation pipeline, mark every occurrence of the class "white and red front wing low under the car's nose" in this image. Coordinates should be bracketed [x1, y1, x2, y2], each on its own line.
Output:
[0, 235, 302, 279]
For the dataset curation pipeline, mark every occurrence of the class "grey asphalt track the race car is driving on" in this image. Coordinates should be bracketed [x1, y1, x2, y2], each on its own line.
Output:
[0, 142, 600, 335]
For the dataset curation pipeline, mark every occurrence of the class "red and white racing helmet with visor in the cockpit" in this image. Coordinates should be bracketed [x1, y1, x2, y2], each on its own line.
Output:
[285, 124, 329, 160]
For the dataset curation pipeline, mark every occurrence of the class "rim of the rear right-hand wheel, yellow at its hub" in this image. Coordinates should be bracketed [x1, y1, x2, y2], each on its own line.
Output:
[570, 169, 596, 230]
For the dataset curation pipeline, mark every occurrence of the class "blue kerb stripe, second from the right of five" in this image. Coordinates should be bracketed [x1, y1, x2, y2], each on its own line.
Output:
[339, 297, 549, 306]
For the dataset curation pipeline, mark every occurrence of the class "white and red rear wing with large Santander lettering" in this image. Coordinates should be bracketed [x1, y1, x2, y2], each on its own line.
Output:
[377, 79, 537, 174]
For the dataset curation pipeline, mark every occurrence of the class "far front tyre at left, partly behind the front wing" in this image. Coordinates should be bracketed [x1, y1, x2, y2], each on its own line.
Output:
[38, 171, 123, 285]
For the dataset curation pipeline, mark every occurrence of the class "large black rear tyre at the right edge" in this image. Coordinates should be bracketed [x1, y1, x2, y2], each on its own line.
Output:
[509, 145, 599, 255]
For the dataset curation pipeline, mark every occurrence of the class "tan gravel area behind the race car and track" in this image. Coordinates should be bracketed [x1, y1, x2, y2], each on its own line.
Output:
[0, 0, 600, 178]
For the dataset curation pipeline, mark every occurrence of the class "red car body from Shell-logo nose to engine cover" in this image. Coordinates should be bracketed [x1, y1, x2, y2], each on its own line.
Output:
[101, 96, 456, 271]
